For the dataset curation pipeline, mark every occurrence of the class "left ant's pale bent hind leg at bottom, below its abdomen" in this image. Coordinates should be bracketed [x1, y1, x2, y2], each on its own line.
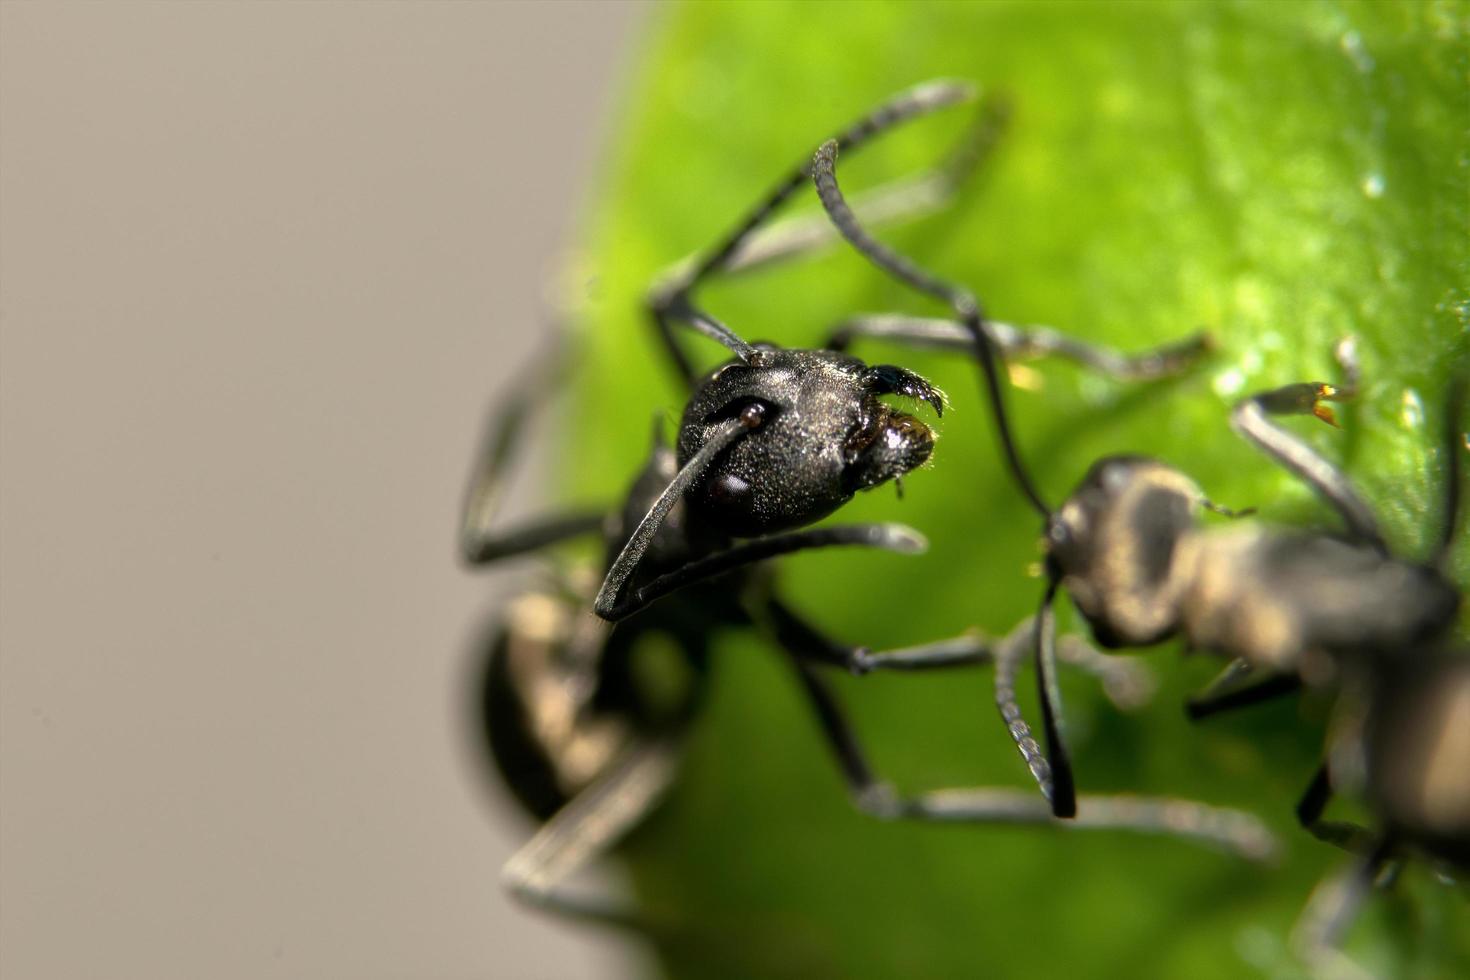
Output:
[501, 738, 681, 933]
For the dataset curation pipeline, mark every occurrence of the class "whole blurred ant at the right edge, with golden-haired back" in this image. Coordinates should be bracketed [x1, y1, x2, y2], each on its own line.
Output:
[946, 326, 1470, 968]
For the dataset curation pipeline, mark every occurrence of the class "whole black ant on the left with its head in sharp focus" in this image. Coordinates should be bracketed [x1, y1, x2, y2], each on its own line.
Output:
[462, 82, 1272, 929]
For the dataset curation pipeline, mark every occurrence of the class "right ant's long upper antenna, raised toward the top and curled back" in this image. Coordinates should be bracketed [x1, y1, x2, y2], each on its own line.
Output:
[811, 140, 1051, 517]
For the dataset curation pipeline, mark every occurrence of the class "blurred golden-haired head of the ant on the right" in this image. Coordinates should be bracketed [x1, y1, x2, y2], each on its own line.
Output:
[1047, 455, 1204, 646]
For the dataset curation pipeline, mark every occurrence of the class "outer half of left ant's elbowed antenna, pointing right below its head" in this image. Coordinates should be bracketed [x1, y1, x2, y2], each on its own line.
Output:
[595, 523, 929, 623]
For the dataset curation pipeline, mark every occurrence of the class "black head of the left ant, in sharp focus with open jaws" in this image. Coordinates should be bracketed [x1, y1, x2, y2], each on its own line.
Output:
[679, 347, 944, 538]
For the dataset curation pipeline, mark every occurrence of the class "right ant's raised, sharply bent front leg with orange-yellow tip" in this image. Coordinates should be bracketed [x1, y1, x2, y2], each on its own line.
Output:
[1230, 338, 1388, 555]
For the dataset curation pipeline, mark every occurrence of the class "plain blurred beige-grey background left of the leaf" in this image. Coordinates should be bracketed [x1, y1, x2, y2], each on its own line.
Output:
[0, 1, 647, 980]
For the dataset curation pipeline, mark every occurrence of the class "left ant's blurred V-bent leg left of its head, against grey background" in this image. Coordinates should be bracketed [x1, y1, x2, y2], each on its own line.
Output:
[459, 350, 603, 566]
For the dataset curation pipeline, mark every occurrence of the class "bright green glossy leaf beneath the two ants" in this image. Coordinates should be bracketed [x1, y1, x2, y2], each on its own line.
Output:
[566, 3, 1470, 977]
